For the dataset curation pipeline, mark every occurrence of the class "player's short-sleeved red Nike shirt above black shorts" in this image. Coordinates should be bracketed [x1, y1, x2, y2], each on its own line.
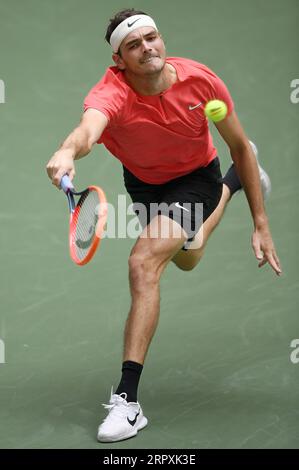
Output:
[84, 57, 234, 184]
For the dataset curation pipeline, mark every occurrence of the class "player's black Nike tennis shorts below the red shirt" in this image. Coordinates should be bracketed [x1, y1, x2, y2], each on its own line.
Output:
[123, 157, 222, 241]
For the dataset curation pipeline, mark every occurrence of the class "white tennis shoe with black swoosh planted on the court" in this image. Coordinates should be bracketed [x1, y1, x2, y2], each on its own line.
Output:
[98, 388, 147, 442]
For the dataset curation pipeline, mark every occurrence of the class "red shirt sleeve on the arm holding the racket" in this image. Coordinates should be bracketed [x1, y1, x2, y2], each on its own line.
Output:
[83, 71, 126, 127]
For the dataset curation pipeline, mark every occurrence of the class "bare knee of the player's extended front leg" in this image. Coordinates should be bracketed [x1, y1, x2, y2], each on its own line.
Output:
[129, 253, 160, 288]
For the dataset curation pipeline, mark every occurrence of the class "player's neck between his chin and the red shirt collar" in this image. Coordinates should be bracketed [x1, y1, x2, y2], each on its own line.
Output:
[124, 63, 177, 96]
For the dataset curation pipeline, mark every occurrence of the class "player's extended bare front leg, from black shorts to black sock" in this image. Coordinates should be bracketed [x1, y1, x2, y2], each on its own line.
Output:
[123, 216, 187, 364]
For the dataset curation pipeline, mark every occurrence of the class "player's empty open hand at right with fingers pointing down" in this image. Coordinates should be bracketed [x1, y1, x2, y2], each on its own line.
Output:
[251, 224, 282, 276]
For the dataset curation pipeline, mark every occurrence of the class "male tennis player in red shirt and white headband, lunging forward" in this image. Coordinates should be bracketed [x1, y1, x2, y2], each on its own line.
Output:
[47, 9, 282, 442]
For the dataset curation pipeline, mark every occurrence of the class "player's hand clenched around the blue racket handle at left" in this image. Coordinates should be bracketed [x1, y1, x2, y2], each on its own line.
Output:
[47, 149, 75, 189]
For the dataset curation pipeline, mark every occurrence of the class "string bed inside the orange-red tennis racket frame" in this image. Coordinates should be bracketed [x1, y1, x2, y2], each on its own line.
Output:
[74, 190, 100, 260]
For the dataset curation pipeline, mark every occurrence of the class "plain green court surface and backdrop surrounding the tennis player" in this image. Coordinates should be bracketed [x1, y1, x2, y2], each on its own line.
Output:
[0, 0, 299, 449]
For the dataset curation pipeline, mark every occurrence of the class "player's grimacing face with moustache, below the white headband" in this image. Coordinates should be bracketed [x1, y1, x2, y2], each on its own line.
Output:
[113, 26, 166, 75]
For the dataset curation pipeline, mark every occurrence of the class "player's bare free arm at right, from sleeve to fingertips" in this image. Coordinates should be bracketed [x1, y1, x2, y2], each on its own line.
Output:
[215, 111, 282, 275]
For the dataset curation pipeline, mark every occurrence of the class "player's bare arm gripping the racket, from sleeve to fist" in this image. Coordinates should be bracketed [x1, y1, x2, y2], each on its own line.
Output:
[47, 108, 108, 188]
